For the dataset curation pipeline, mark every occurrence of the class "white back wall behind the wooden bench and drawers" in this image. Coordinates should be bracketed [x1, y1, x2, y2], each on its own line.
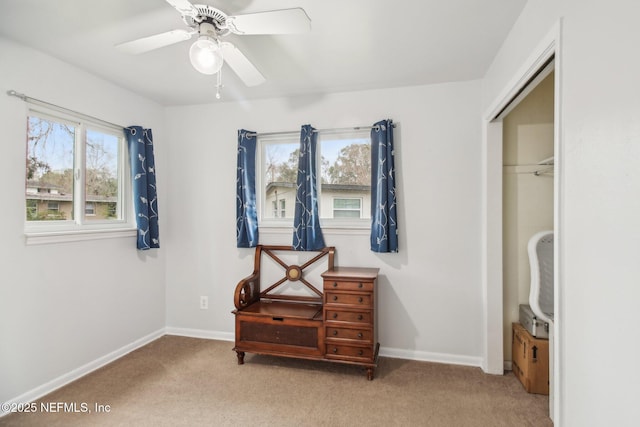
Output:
[164, 81, 483, 365]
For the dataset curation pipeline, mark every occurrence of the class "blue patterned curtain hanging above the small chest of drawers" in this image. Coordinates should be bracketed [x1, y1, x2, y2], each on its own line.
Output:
[371, 120, 398, 252]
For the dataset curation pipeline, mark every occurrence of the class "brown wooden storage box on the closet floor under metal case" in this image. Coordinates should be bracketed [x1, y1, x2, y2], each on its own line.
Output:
[512, 323, 549, 395]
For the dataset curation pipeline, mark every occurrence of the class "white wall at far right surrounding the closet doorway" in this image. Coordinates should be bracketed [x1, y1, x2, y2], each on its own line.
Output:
[483, 0, 640, 426]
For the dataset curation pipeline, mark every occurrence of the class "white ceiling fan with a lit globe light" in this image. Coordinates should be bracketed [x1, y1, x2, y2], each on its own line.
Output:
[116, 0, 311, 86]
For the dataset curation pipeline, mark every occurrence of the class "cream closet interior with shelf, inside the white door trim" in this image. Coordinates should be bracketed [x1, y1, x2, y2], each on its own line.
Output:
[500, 61, 555, 378]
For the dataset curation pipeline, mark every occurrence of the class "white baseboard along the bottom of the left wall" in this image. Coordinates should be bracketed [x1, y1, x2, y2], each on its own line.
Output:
[0, 328, 165, 418]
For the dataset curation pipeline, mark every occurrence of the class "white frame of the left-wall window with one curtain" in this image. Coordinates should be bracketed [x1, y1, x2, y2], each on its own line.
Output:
[23, 104, 136, 244]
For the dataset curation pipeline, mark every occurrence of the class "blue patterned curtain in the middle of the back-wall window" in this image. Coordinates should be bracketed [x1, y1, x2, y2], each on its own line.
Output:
[293, 125, 324, 251]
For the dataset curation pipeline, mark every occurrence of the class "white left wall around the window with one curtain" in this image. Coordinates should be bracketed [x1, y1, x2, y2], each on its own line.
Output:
[0, 38, 166, 402]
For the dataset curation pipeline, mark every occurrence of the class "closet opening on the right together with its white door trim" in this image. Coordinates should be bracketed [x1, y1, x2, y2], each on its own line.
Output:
[483, 40, 561, 420]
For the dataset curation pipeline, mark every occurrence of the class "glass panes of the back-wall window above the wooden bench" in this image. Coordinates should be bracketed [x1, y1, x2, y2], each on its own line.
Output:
[256, 130, 371, 228]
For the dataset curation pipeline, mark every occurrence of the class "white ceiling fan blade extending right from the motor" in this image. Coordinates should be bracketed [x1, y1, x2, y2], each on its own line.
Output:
[227, 7, 311, 34]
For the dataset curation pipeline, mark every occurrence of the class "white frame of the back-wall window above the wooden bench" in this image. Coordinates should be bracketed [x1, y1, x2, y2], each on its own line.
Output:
[256, 129, 371, 233]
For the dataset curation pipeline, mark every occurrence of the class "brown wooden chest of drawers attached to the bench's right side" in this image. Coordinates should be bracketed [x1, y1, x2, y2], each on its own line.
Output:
[322, 267, 380, 380]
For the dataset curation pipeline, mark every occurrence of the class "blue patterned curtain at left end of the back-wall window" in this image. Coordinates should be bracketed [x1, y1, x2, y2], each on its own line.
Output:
[236, 129, 258, 248]
